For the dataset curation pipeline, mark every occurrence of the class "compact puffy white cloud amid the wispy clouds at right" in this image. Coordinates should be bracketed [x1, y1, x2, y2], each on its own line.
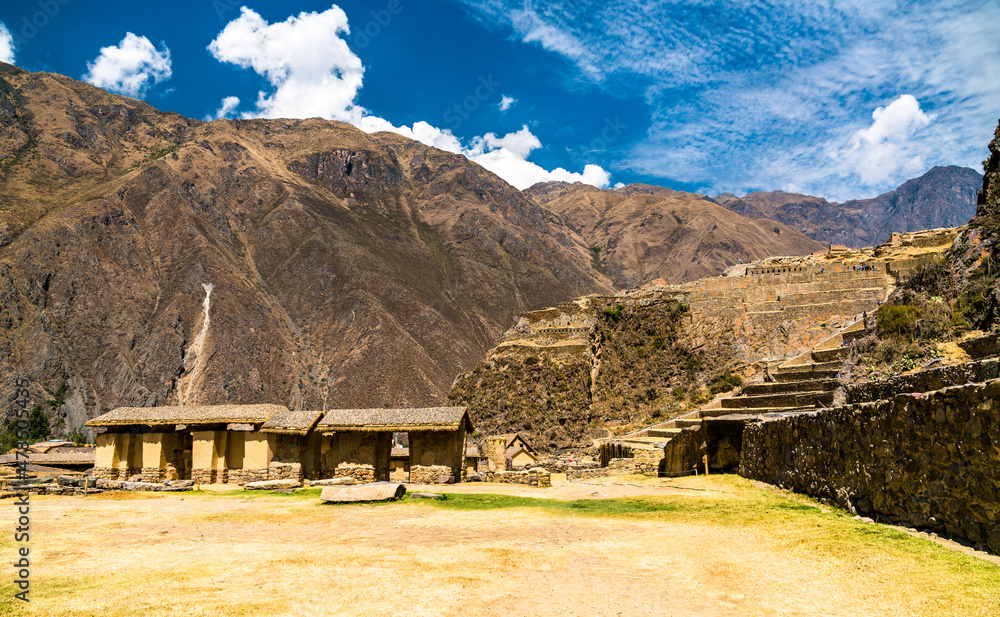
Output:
[844, 94, 932, 185]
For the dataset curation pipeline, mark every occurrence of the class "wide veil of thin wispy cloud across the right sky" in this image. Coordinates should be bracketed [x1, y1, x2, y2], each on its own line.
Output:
[461, 0, 1000, 199]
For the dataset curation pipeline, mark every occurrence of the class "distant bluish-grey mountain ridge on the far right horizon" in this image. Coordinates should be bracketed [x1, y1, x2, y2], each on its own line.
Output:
[713, 165, 983, 248]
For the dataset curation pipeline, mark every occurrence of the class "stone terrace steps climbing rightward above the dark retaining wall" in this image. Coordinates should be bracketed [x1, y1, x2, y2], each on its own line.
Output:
[600, 321, 867, 465]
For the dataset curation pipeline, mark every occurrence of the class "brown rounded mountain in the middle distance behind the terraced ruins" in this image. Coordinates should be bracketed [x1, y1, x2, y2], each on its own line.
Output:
[526, 182, 824, 288]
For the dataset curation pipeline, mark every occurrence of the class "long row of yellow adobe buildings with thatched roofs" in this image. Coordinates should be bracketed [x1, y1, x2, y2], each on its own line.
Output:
[87, 405, 472, 484]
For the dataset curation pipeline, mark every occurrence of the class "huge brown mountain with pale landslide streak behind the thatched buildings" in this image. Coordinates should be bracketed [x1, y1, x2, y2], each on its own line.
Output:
[0, 65, 610, 431]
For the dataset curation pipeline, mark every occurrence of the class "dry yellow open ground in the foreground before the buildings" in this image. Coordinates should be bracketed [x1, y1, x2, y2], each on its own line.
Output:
[0, 479, 1000, 617]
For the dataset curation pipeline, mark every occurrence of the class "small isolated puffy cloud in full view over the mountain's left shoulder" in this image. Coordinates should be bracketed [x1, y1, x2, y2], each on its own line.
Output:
[83, 32, 171, 96]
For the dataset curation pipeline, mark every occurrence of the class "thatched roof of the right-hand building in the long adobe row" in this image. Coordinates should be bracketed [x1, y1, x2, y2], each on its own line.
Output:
[316, 407, 472, 433]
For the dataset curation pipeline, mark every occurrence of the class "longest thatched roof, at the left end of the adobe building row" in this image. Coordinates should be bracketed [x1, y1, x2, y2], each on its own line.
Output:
[87, 405, 288, 426]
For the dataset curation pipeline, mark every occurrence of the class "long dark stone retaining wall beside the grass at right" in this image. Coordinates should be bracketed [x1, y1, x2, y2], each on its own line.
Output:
[740, 380, 1000, 553]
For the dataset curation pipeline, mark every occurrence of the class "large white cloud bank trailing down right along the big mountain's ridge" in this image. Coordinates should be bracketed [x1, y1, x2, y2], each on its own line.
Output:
[208, 6, 611, 189]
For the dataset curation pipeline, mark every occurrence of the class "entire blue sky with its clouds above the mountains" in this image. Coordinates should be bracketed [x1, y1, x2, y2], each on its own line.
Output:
[0, 0, 1000, 201]
